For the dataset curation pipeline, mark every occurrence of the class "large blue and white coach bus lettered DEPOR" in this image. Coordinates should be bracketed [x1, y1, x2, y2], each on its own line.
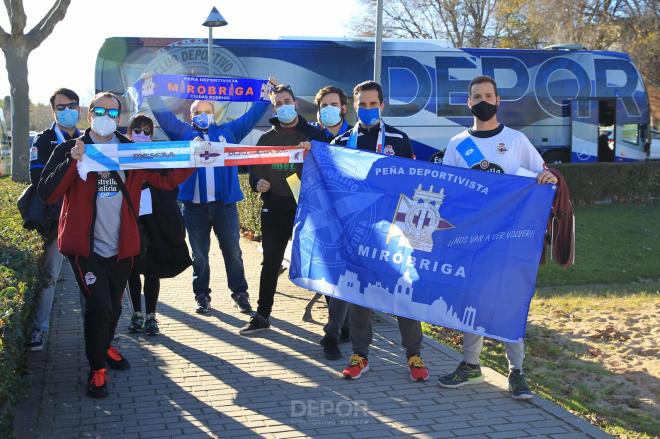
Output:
[95, 37, 650, 163]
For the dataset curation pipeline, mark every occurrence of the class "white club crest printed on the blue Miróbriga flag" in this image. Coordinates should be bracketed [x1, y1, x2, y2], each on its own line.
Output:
[386, 184, 454, 252]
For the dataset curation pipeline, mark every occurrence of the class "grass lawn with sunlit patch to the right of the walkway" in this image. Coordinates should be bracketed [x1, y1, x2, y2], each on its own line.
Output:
[424, 204, 660, 439]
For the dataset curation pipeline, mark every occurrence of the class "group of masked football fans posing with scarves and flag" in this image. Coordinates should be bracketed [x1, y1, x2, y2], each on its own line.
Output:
[28, 76, 556, 399]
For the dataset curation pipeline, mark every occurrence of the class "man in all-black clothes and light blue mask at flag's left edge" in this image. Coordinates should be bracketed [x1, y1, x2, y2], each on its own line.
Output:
[239, 85, 326, 335]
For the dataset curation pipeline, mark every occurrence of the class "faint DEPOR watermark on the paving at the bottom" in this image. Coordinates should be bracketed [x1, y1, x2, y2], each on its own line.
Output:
[290, 399, 369, 425]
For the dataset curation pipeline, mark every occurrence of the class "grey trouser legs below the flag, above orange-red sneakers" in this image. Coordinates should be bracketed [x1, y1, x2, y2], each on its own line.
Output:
[348, 304, 423, 357]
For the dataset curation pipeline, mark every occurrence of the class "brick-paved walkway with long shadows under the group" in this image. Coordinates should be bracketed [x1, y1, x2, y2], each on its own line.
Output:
[15, 241, 608, 439]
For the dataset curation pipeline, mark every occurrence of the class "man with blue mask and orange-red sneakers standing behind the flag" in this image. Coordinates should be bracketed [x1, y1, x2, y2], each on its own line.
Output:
[330, 81, 429, 381]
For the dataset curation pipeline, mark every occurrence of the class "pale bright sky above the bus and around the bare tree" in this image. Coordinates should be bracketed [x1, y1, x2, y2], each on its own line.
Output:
[0, 0, 360, 103]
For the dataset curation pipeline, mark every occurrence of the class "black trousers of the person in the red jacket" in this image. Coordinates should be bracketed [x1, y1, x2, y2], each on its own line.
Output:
[69, 254, 133, 370]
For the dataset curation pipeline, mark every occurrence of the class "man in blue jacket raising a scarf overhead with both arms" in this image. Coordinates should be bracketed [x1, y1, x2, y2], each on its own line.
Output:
[147, 78, 276, 314]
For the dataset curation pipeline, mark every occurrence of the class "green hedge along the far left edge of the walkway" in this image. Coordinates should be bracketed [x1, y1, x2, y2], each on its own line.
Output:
[0, 177, 43, 437]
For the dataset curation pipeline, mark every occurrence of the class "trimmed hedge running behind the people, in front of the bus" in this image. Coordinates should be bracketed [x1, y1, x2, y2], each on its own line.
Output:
[238, 161, 660, 239]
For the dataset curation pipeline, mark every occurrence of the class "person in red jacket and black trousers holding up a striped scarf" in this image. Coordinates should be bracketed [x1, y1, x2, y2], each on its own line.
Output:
[38, 93, 192, 398]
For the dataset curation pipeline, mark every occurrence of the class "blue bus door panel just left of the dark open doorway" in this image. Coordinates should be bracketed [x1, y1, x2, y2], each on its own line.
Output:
[571, 99, 599, 163]
